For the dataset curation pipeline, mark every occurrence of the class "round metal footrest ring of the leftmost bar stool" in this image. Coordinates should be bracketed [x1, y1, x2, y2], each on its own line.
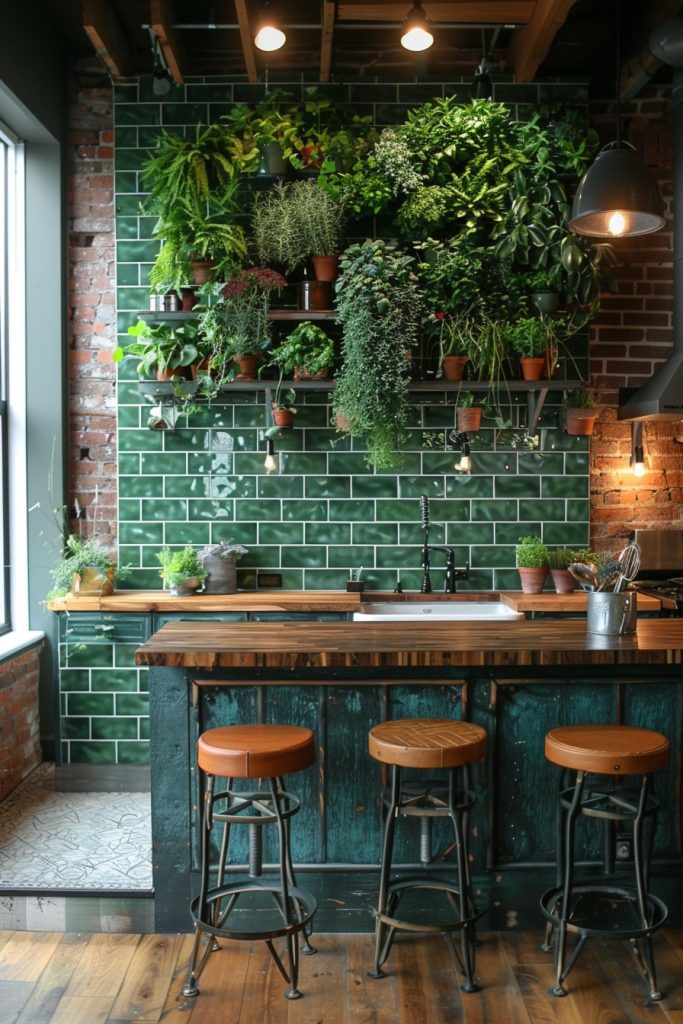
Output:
[190, 880, 317, 941]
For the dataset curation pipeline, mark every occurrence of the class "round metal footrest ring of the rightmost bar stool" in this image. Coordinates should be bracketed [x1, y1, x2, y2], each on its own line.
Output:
[541, 883, 669, 939]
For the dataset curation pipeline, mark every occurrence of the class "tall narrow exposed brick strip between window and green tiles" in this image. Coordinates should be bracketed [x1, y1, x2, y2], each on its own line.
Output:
[67, 58, 117, 543]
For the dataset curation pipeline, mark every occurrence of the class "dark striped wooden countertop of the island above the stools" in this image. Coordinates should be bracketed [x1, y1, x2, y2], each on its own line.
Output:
[135, 618, 683, 670]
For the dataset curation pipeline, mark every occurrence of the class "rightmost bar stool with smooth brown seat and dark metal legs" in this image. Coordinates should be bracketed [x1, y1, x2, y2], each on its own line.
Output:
[541, 725, 669, 999]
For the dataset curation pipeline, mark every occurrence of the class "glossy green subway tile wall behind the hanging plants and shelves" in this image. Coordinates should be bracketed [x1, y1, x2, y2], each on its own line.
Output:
[115, 77, 589, 589]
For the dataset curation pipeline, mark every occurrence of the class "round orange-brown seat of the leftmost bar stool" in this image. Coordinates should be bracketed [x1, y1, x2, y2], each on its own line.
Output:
[197, 725, 315, 778]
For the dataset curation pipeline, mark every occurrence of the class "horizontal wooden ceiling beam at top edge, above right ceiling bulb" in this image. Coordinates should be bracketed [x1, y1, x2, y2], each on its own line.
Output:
[337, 0, 538, 25]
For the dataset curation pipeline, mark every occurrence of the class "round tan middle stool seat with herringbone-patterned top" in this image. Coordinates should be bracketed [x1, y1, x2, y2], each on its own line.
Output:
[368, 718, 486, 768]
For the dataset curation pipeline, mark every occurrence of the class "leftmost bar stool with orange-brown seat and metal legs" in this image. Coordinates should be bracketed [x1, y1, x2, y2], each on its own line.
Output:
[182, 725, 315, 999]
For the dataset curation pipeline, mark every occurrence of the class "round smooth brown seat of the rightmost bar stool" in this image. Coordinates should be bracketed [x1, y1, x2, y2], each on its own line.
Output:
[546, 725, 670, 775]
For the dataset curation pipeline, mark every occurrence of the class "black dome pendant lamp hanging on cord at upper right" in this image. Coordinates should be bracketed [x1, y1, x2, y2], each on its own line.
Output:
[569, 2, 665, 239]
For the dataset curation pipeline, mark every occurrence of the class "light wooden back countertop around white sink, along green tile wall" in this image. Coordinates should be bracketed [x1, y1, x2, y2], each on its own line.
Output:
[48, 590, 659, 614]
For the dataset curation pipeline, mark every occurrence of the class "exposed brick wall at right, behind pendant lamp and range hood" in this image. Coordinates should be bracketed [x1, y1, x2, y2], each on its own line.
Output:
[591, 86, 683, 548]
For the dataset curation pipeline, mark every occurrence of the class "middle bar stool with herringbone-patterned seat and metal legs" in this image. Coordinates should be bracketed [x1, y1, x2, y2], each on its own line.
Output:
[368, 719, 486, 992]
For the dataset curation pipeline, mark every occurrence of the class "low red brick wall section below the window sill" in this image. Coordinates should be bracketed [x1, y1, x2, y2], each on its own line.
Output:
[0, 646, 41, 800]
